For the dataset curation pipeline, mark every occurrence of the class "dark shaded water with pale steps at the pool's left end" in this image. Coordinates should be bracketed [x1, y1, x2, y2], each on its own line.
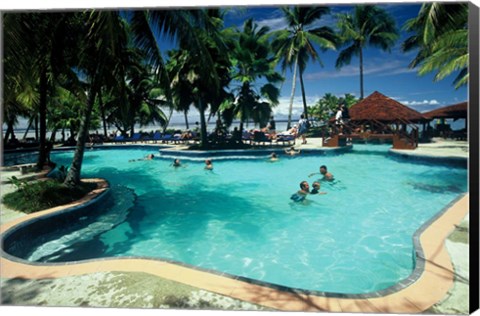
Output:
[5, 167, 268, 262]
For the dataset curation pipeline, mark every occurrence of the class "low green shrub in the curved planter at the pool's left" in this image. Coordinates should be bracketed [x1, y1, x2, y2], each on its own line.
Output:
[2, 177, 97, 214]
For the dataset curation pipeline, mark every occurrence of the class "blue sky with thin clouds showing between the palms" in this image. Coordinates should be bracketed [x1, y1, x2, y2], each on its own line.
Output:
[217, 3, 467, 117]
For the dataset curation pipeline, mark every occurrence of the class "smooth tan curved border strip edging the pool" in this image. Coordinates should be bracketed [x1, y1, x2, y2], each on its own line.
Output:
[0, 179, 469, 313]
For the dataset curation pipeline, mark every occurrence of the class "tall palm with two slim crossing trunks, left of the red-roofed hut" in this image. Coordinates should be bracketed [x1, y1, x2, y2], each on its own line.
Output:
[273, 6, 337, 128]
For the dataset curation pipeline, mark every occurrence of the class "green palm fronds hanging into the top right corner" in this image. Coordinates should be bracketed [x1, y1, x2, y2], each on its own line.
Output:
[402, 3, 468, 89]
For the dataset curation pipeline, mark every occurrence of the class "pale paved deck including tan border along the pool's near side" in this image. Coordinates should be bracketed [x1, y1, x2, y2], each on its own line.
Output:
[0, 141, 469, 314]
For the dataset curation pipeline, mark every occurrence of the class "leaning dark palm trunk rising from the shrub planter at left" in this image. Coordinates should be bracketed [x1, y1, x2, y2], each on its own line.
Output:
[63, 87, 96, 187]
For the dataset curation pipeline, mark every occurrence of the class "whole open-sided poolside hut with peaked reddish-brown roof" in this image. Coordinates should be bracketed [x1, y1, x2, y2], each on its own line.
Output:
[323, 91, 428, 149]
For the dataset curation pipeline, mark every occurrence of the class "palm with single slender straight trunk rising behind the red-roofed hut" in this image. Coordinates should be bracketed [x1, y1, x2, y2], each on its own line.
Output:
[335, 5, 399, 100]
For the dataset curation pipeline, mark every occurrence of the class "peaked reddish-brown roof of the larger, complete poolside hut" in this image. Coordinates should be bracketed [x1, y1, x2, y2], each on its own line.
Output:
[349, 91, 427, 123]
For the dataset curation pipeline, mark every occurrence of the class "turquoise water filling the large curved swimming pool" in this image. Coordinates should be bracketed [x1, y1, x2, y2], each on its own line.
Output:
[14, 145, 467, 294]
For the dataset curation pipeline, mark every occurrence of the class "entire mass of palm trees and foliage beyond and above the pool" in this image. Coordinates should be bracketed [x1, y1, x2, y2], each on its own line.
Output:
[2, 3, 468, 187]
